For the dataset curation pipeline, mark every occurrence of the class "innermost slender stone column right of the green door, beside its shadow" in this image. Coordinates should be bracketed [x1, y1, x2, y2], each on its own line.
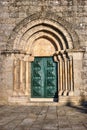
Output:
[58, 55, 63, 96]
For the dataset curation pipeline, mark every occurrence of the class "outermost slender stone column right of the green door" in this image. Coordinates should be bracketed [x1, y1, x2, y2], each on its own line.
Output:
[69, 56, 74, 96]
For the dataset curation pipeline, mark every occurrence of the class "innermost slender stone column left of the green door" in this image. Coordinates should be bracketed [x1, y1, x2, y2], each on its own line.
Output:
[25, 61, 29, 95]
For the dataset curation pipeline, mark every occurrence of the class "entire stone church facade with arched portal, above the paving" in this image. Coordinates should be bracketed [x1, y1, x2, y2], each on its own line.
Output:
[0, 0, 87, 104]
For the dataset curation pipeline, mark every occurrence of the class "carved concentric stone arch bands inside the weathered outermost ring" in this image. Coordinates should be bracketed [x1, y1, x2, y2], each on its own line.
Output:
[13, 19, 73, 51]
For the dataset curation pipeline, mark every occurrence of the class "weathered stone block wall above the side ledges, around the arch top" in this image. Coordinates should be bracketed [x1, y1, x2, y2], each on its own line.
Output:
[0, 0, 87, 49]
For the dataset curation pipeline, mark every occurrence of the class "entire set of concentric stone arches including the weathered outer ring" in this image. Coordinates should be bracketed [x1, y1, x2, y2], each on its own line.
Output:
[7, 13, 79, 51]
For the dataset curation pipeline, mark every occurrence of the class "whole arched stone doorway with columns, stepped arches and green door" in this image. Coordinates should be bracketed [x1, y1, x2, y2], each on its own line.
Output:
[7, 14, 82, 101]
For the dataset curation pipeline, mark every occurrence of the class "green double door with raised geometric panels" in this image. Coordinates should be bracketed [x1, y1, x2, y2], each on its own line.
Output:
[31, 57, 57, 98]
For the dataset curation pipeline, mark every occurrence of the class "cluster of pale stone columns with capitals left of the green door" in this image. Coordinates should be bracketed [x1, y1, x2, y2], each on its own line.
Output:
[12, 54, 34, 96]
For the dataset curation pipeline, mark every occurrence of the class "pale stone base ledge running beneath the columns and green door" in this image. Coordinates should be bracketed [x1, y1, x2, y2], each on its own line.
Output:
[8, 96, 80, 106]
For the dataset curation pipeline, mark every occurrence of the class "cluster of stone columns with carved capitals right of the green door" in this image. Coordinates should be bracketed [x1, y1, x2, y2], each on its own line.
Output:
[54, 50, 74, 96]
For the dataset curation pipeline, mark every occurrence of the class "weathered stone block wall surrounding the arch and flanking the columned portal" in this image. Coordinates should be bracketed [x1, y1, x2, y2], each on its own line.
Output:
[0, 0, 87, 101]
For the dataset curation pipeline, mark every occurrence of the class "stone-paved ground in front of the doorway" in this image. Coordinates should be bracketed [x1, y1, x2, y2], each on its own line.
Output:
[0, 106, 87, 130]
